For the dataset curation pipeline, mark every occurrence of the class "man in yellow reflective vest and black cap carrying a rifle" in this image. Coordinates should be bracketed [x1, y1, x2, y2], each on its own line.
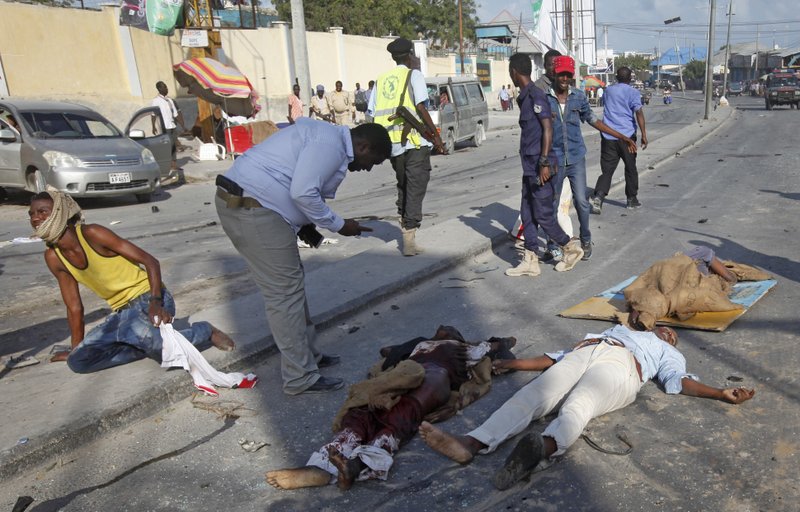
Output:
[368, 37, 446, 256]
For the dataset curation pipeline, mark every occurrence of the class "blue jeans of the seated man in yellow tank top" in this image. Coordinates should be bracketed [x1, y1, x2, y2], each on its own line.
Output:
[67, 289, 211, 373]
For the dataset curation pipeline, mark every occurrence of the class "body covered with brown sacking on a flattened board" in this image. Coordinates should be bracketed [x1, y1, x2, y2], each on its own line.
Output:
[620, 246, 771, 330]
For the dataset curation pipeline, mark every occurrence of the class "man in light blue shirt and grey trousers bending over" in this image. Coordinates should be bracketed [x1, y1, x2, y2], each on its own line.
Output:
[215, 118, 392, 395]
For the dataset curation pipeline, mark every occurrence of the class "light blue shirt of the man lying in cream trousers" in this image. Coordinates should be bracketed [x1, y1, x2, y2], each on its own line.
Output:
[546, 325, 697, 395]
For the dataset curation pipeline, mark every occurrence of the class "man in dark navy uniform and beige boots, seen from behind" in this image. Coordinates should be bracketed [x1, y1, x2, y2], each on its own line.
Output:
[506, 53, 583, 277]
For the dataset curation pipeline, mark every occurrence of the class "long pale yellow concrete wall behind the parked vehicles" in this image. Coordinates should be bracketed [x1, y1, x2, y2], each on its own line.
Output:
[0, 0, 508, 126]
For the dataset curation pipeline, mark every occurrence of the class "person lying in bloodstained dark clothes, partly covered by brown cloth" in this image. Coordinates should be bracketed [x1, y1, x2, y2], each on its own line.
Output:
[267, 326, 516, 490]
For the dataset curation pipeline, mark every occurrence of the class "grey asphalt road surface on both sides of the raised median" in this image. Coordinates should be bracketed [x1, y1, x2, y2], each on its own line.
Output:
[0, 97, 800, 512]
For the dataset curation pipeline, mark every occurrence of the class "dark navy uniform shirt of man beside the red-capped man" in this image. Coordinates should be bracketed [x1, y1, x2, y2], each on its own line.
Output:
[517, 82, 552, 176]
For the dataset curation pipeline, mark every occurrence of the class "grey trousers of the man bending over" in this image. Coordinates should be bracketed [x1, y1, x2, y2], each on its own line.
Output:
[214, 197, 322, 395]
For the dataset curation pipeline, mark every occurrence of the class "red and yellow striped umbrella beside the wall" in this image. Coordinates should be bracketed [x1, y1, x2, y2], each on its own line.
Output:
[173, 57, 260, 117]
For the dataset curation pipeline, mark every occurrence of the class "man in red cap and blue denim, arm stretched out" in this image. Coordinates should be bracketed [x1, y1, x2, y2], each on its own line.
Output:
[545, 56, 636, 261]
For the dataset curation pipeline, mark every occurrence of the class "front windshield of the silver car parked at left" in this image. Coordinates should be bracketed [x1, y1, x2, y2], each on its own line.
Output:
[21, 112, 122, 139]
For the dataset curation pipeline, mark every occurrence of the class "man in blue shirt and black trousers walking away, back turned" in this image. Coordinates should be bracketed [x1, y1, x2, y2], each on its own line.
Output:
[589, 67, 647, 215]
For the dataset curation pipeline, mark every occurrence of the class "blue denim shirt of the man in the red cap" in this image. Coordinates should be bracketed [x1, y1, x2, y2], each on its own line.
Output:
[547, 87, 597, 167]
